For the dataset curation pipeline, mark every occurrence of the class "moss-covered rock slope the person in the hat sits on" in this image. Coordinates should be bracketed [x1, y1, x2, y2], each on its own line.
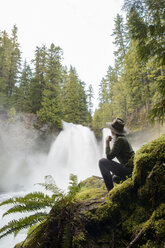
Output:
[16, 136, 165, 248]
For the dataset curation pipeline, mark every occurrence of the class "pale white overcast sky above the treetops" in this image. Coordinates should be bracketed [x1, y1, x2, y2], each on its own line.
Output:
[0, 0, 124, 108]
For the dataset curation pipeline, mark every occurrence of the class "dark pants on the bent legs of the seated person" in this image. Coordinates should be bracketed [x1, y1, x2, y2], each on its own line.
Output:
[99, 158, 132, 191]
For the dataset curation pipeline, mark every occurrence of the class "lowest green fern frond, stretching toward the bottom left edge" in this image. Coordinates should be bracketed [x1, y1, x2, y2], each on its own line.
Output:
[0, 212, 47, 239]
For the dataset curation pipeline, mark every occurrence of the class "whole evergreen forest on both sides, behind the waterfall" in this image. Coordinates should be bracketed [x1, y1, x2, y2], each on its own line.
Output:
[0, 0, 165, 130]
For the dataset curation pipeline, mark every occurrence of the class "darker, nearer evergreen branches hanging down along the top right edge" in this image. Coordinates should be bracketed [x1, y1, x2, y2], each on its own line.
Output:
[124, 0, 165, 122]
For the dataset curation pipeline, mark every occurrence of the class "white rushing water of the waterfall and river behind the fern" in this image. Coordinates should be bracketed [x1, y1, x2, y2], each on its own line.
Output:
[0, 122, 105, 248]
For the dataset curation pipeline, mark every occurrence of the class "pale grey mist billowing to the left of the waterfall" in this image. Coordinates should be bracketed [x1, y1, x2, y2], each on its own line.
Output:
[0, 118, 50, 192]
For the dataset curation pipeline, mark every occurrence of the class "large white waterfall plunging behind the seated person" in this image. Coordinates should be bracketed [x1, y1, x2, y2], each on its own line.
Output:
[45, 122, 101, 188]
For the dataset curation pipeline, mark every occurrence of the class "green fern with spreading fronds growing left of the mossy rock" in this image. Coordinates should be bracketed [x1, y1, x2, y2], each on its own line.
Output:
[0, 174, 80, 239]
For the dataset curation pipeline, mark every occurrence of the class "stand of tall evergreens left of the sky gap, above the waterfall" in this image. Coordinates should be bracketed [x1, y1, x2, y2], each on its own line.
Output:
[0, 26, 93, 130]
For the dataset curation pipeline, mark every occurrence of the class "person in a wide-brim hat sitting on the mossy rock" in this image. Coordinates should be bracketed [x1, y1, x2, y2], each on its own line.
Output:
[99, 118, 135, 192]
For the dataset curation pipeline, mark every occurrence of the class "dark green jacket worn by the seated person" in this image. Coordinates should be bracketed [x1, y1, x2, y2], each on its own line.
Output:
[106, 136, 135, 167]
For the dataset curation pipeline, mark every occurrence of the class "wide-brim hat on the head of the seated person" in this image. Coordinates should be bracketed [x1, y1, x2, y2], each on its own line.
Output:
[106, 118, 128, 135]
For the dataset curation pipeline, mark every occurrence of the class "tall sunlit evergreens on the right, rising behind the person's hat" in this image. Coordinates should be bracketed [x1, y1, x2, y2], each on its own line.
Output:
[93, 0, 165, 130]
